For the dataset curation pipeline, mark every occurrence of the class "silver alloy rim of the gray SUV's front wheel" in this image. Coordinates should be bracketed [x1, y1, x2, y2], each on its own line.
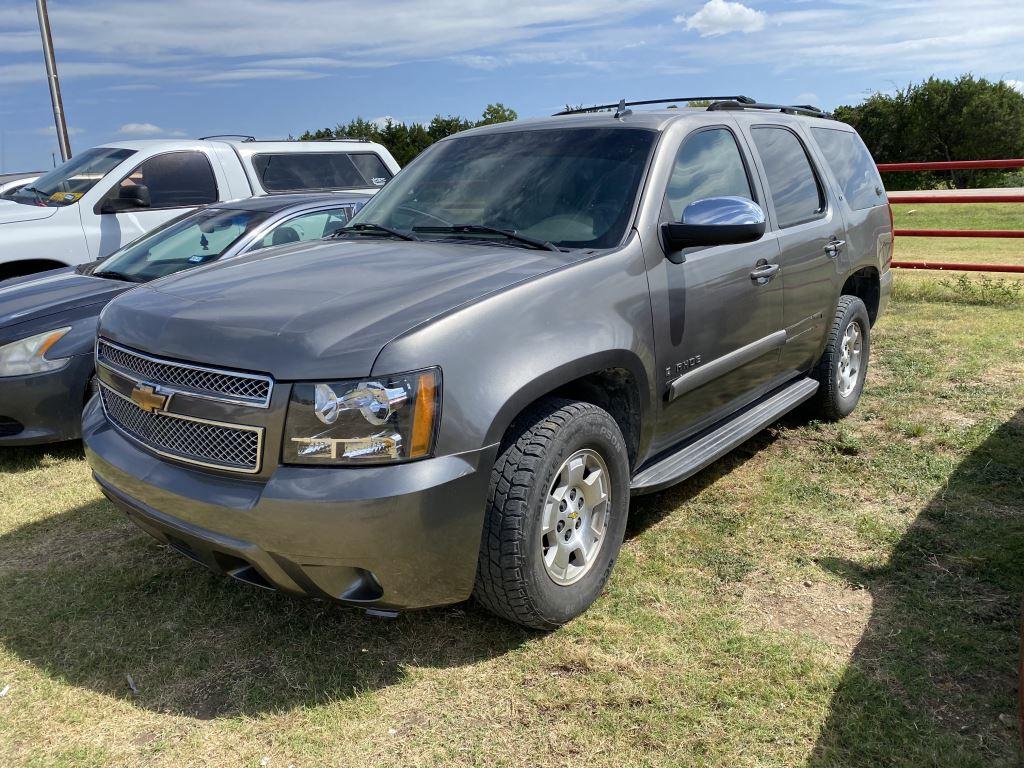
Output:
[540, 449, 611, 587]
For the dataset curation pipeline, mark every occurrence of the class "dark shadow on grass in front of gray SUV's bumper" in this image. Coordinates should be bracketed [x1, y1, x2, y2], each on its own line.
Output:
[0, 501, 537, 719]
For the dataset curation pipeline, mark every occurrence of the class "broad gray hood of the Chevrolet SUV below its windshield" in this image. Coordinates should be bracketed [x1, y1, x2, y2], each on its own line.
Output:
[100, 241, 580, 380]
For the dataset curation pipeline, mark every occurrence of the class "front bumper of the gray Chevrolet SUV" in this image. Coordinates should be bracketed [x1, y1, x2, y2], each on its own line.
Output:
[82, 397, 498, 609]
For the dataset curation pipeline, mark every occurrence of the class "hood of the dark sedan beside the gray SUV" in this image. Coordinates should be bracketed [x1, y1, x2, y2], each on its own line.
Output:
[0, 267, 134, 327]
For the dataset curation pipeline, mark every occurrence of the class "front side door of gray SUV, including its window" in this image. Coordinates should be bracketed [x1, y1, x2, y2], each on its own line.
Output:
[651, 125, 785, 451]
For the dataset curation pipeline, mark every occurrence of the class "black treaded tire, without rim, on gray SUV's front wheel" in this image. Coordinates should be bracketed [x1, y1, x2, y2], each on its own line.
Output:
[473, 397, 630, 630]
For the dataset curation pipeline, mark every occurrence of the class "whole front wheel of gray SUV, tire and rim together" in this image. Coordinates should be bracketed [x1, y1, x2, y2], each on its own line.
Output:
[473, 398, 630, 630]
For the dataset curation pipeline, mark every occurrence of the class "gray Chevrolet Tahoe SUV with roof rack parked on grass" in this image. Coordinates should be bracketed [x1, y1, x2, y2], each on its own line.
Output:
[83, 97, 892, 629]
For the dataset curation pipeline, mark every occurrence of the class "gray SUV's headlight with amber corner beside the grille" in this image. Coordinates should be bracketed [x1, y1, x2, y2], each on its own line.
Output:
[283, 368, 441, 464]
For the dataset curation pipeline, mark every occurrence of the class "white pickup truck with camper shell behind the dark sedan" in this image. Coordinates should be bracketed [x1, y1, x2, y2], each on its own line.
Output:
[0, 137, 398, 280]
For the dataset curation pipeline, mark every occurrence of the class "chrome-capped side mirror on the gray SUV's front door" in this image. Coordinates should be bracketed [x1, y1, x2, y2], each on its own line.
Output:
[662, 197, 765, 264]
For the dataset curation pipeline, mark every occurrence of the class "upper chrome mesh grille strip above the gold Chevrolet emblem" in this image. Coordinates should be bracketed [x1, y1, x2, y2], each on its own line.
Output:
[96, 339, 273, 408]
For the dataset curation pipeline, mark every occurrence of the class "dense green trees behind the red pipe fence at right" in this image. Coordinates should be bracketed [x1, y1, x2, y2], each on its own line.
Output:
[836, 74, 1024, 188]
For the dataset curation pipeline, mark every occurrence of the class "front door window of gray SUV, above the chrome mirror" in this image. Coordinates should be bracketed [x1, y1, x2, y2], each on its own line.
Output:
[667, 128, 754, 221]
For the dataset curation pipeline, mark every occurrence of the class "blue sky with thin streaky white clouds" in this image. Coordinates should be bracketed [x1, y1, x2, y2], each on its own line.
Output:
[0, 0, 1024, 170]
